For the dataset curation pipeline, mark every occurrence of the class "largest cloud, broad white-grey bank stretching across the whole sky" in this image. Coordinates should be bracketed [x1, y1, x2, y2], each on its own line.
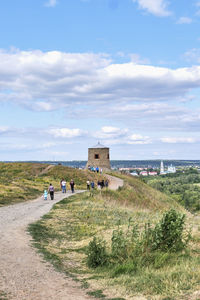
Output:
[0, 50, 200, 111]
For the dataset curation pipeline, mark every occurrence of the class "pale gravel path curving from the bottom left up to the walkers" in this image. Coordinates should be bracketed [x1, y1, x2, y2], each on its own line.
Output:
[0, 191, 91, 300]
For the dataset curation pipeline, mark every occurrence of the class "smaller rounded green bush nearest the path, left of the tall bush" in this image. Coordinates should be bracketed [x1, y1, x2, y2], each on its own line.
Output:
[87, 237, 108, 268]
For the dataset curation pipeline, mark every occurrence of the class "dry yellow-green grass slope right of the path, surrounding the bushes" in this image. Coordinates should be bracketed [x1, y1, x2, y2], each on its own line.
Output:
[30, 176, 200, 299]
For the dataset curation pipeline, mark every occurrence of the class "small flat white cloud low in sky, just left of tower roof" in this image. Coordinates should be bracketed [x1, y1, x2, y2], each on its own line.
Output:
[47, 128, 85, 138]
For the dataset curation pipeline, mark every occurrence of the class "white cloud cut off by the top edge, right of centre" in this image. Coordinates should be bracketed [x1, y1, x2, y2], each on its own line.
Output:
[133, 0, 171, 17]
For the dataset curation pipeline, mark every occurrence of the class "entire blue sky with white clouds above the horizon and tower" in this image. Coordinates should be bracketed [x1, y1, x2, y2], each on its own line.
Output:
[0, 0, 200, 161]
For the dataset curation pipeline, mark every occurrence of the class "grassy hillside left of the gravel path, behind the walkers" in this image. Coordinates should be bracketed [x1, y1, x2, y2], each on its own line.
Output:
[0, 163, 103, 206]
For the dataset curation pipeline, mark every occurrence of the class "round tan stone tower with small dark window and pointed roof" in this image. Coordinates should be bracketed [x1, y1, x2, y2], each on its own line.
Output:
[86, 142, 110, 170]
